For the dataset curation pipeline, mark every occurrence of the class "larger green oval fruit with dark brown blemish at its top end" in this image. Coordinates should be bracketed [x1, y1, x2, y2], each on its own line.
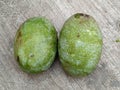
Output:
[58, 13, 103, 76]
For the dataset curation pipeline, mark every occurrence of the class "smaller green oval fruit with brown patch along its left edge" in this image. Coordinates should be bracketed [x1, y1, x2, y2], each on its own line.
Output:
[14, 17, 57, 73]
